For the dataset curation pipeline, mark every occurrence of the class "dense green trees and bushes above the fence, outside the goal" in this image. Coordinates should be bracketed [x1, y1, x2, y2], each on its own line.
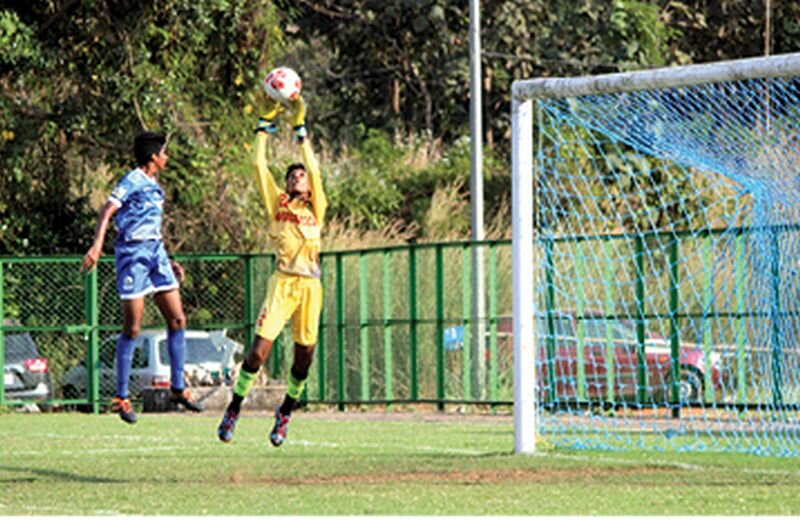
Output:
[0, 0, 800, 254]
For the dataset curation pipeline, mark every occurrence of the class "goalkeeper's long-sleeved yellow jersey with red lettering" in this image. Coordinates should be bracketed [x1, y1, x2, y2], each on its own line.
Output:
[254, 132, 328, 278]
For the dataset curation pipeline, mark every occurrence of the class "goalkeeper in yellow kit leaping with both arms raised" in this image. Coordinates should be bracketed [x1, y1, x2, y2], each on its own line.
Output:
[217, 93, 328, 447]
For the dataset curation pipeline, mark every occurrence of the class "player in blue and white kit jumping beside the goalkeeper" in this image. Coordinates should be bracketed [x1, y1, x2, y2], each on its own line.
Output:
[81, 132, 203, 424]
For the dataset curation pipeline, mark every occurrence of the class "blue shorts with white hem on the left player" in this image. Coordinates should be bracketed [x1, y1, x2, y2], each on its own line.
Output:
[114, 240, 179, 300]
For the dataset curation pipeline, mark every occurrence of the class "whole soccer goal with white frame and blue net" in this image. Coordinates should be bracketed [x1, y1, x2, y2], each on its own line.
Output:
[511, 53, 800, 454]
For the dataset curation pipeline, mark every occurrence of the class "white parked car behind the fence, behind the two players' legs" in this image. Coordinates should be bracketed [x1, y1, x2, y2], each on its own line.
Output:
[64, 329, 243, 399]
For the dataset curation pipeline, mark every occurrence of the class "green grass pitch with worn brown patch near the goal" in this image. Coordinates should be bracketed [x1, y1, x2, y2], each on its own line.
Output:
[0, 412, 800, 516]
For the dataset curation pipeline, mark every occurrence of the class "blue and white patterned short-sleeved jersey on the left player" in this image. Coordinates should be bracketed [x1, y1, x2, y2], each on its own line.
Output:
[108, 168, 164, 244]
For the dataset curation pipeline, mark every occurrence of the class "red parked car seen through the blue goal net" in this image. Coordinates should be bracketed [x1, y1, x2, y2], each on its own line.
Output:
[444, 311, 722, 403]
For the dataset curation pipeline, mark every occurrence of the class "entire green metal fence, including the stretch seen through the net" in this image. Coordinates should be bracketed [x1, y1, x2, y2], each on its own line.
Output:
[0, 233, 800, 411]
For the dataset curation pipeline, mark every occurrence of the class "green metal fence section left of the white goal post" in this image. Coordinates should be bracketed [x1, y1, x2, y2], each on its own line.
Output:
[0, 241, 512, 411]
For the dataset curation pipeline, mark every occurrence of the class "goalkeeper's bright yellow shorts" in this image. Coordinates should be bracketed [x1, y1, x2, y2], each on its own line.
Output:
[256, 272, 322, 347]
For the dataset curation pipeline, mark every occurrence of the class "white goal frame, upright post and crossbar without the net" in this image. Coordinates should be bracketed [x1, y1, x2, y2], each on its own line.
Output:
[511, 53, 800, 453]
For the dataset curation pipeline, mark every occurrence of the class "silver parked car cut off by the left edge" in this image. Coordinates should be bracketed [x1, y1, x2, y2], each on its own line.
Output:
[3, 332, 52, 401]
